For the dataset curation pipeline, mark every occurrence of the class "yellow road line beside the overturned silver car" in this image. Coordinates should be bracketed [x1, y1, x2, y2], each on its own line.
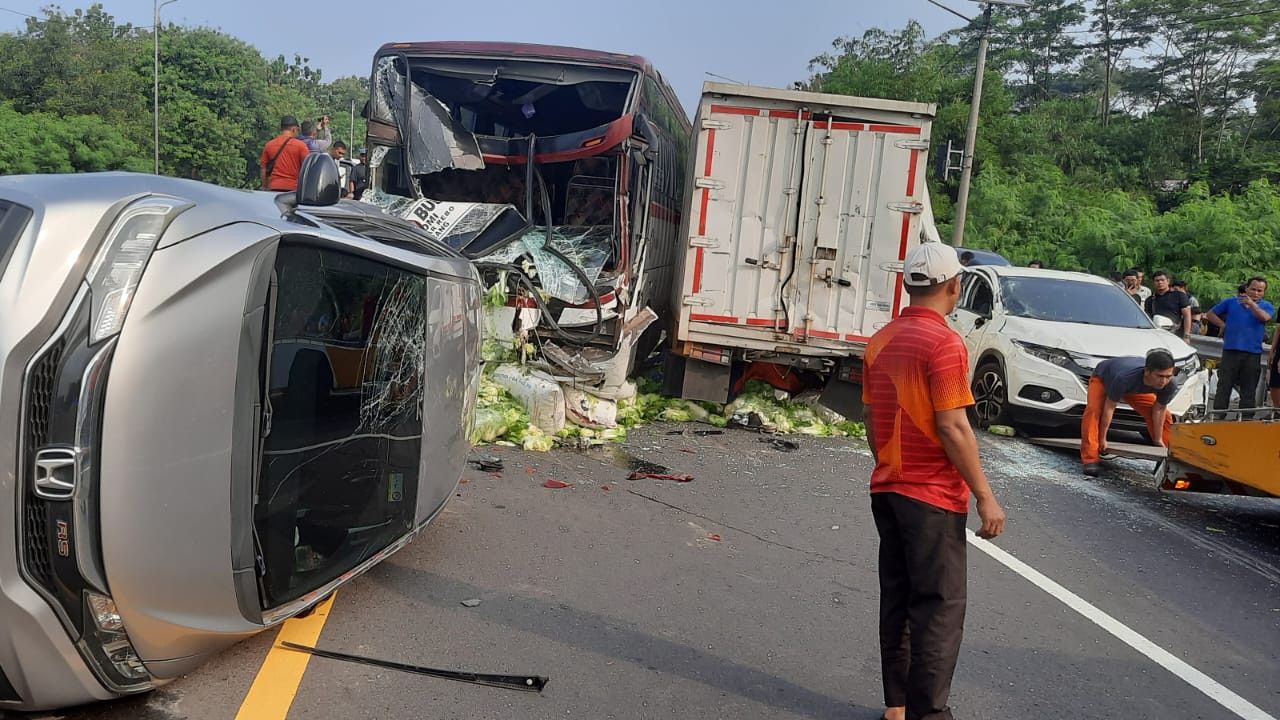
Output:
[236, 593, 338, 720]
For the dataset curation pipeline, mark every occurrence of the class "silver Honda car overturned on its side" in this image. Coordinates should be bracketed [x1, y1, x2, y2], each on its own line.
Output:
[0, 155, 481, 710]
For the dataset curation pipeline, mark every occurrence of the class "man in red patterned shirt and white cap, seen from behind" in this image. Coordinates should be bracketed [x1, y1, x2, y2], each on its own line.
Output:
[863, 242, 1005, 720]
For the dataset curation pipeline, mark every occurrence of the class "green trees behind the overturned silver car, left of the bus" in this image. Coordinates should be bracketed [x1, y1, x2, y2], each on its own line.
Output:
[0, 4, 367, 187]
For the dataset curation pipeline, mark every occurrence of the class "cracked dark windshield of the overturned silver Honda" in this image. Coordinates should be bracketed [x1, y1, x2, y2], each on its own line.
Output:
[255, 245, 426, 607]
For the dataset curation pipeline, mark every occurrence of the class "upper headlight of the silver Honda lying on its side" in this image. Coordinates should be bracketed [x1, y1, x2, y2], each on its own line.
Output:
[84, 196, 191, 343]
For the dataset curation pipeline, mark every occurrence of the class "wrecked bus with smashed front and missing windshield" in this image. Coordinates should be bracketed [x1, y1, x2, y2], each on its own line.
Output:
[364, 42, 691, 387]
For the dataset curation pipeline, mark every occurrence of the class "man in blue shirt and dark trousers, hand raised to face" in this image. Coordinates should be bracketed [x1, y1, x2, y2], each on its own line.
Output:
[1206, 277, 1276, 410]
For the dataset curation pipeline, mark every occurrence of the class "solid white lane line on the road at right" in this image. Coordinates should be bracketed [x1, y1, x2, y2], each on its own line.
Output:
[965, 529, 1276, 720]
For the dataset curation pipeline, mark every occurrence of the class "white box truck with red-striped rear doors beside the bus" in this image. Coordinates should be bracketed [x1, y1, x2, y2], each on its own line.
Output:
[666, 82, 937, 416]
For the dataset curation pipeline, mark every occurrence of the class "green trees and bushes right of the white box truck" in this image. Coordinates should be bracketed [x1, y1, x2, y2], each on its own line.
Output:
[796, 0, 1280, 304]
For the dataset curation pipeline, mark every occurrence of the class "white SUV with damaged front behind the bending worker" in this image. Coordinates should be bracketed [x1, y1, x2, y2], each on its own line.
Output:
[948, 265, 1207, 434]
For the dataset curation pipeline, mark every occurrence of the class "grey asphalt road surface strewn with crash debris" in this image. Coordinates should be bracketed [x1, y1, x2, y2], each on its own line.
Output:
[17, 425, 1280, 720]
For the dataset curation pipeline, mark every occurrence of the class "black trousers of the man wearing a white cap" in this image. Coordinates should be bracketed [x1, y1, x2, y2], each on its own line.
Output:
[872, 492, 966, 720]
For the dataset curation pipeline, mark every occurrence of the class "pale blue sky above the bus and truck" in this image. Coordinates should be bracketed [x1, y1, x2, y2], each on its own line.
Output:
[0, 0, 977, 114]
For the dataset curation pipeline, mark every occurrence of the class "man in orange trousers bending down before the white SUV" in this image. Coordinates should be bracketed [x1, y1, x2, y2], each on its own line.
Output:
[1080, 348, 1178, 477]
